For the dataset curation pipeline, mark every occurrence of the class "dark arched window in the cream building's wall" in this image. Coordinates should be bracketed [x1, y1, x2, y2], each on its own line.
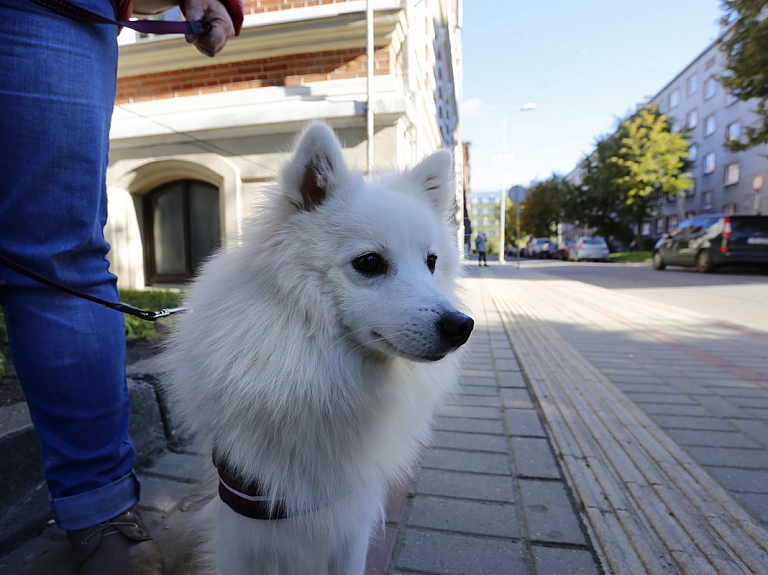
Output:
[142, 180, 221, 285]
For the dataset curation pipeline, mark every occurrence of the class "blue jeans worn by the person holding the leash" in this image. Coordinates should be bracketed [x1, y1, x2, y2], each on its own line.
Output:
[0, 0, 139, 530]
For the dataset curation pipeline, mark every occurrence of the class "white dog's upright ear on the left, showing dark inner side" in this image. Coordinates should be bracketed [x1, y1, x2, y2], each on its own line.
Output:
[281, 122, 347, 211]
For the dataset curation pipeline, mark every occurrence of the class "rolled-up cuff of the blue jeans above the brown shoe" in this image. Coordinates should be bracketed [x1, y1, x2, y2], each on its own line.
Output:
[50, 471, 141, 531]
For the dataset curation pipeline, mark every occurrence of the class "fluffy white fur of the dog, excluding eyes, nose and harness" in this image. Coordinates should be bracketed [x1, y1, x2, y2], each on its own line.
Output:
[163, 123, 472, 575]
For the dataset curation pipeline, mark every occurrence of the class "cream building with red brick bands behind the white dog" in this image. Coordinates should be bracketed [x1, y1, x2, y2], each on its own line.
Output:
[105, 0, 465, 288]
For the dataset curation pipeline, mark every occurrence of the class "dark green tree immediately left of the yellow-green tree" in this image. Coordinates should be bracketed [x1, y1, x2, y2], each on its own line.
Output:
[562, 126, 631, 244]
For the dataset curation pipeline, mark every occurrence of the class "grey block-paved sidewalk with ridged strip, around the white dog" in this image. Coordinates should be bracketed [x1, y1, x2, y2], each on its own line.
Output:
[0, 264, 768, 575]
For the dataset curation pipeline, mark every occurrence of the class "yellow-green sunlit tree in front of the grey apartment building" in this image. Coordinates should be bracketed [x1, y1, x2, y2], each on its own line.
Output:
[612, 106, 692, 245]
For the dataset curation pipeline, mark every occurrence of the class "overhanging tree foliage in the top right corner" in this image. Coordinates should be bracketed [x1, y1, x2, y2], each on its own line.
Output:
[720, 0, 768, 151]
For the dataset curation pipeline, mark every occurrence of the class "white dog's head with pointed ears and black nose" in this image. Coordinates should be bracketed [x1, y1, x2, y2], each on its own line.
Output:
[270, 123, 474, 361]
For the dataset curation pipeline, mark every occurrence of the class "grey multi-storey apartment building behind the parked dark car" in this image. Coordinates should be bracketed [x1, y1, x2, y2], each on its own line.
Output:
[649, 37, 768, 236]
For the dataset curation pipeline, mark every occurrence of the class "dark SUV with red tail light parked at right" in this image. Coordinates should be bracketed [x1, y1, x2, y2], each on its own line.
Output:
[653, 214, 768, 274]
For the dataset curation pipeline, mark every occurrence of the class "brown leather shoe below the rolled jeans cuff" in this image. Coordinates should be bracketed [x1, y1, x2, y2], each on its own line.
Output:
[67, 505, 165, 575]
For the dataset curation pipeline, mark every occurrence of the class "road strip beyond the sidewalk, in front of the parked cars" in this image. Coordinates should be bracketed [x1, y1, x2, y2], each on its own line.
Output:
[505, 259, 768, 332]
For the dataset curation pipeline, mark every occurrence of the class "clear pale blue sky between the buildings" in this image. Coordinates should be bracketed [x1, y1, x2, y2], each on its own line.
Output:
[460, 0, 722, 192]
